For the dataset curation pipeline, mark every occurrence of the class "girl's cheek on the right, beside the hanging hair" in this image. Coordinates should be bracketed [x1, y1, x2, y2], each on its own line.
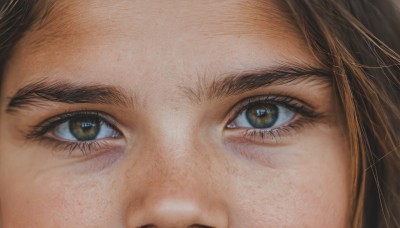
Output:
[228, 134, 350, 228]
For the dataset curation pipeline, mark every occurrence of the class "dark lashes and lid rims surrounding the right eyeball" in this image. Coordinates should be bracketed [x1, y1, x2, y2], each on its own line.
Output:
[227, 95, 323, 143]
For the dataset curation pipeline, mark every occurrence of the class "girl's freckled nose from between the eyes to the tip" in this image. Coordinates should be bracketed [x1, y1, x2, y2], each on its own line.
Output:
[127, 127, 228, 227]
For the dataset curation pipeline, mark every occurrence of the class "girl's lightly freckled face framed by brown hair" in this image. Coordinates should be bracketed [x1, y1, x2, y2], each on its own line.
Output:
[0, 0, 350, 228]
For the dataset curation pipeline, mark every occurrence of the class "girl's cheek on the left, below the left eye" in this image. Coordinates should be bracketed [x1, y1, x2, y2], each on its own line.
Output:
[2, 168, 118, 227]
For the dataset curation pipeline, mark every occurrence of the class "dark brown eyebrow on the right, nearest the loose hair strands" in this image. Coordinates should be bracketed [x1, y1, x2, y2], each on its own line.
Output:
[183, 64, 333, 102]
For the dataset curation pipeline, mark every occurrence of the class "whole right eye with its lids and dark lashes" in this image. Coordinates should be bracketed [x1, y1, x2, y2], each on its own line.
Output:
[226, 95, 324, 144]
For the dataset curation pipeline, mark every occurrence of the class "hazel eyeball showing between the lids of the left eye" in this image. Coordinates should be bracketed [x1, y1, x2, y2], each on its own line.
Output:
[53, 116, 118, 141]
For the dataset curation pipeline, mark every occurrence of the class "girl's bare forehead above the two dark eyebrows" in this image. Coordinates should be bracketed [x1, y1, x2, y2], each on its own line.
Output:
[4, 0, 315, 100]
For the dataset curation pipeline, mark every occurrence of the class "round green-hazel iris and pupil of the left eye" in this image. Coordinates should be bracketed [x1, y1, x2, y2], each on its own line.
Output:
[69, 117, 100, 141]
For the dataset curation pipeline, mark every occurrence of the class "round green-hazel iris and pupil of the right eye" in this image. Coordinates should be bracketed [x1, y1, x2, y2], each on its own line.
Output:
[246, 104, 278, 128]
